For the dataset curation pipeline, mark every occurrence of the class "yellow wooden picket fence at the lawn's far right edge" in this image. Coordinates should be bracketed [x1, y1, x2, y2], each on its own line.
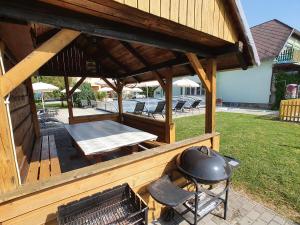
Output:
[279, 99, 300, 122]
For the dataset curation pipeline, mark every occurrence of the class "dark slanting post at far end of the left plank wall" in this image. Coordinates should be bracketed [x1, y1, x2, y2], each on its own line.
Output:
[25, 77, 40, 138]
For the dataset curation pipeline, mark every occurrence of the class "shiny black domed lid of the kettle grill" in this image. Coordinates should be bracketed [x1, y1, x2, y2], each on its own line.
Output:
[176, 146, 231, 184]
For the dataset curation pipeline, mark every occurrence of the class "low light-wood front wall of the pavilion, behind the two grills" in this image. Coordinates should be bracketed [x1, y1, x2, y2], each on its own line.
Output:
[0, 133, 220, 225]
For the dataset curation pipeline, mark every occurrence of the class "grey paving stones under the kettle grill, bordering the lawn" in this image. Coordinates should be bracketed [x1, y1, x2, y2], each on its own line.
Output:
[152, 190, 299, 225]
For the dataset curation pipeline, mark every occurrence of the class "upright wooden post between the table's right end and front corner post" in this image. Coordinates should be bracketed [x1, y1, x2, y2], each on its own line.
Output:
[165, 69, 175, 143]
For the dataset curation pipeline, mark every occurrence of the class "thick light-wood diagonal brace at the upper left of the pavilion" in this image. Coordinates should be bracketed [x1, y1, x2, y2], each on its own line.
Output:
[0, 29, 80, 97]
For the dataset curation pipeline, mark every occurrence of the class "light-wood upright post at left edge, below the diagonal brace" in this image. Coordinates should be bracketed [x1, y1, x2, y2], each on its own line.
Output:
[0, 46, 19, 194]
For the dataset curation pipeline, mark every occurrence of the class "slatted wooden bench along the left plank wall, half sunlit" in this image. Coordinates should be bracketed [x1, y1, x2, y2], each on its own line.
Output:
[26, 135, 61, 183]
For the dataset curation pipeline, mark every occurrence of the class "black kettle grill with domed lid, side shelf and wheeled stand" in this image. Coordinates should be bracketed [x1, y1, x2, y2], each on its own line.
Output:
[148, 146, 239, 224]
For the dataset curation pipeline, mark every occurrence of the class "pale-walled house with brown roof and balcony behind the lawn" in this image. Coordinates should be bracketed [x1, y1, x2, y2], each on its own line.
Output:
[217, 20, 300, 108]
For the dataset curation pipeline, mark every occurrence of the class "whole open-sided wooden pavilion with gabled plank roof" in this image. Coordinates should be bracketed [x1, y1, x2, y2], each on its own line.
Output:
[0, 0, 259, 224]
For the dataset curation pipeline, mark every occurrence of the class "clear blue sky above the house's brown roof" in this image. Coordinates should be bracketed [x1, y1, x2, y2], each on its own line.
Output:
[241, 0, 300, 31]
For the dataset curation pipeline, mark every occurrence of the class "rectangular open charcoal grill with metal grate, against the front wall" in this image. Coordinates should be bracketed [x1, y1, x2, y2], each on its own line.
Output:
[58, 184, 148, 225]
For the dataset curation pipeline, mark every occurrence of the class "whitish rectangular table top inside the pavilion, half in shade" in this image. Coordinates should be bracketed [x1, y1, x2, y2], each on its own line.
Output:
[65, 120, 157, 155]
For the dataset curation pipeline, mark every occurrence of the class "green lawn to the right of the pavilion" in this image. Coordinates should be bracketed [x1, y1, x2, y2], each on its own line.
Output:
[175, 113, 300, 222]
